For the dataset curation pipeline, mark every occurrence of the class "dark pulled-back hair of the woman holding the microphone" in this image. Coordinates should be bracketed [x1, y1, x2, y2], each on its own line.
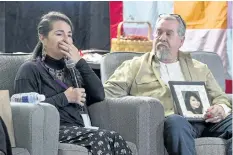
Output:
[32, 11, 74, 59]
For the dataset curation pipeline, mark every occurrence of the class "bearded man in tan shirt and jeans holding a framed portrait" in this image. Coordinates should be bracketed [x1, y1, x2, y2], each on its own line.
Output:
[104, 14, 232, 155]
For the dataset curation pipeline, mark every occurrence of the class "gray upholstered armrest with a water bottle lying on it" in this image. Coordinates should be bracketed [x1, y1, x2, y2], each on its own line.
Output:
[11, 102, 59, 155]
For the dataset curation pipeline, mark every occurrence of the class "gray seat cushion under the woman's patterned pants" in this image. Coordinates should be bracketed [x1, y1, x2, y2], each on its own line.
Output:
[58, 142, 137, 155]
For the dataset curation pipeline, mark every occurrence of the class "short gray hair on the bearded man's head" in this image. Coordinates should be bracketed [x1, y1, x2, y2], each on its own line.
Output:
[155, 14, 186, 37]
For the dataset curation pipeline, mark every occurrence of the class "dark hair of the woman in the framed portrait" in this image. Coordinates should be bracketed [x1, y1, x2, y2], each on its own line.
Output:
[185, 91, 203, 114]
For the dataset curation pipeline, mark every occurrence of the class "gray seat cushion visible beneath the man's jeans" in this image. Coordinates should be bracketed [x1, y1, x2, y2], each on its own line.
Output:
[195, 137, 226, 155]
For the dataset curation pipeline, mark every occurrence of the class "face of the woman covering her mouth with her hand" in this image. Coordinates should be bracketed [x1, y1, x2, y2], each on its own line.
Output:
[40, 20, 73, 60]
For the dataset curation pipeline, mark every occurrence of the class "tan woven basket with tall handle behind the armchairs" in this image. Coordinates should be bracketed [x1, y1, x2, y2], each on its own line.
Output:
[111, 21, 152, 52]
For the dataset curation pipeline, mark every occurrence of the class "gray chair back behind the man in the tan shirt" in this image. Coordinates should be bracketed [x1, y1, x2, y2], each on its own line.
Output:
[100, 51, 225, 91]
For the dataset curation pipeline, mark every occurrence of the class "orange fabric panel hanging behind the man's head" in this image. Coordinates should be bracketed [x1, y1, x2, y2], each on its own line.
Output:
[174, 1, 227, 29]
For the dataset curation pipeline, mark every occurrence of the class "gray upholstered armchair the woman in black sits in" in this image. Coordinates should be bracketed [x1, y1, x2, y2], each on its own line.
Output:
[0, 54, 149, 155]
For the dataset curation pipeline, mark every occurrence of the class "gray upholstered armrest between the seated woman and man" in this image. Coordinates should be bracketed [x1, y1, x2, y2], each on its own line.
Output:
[88, 96, 164, 155]
